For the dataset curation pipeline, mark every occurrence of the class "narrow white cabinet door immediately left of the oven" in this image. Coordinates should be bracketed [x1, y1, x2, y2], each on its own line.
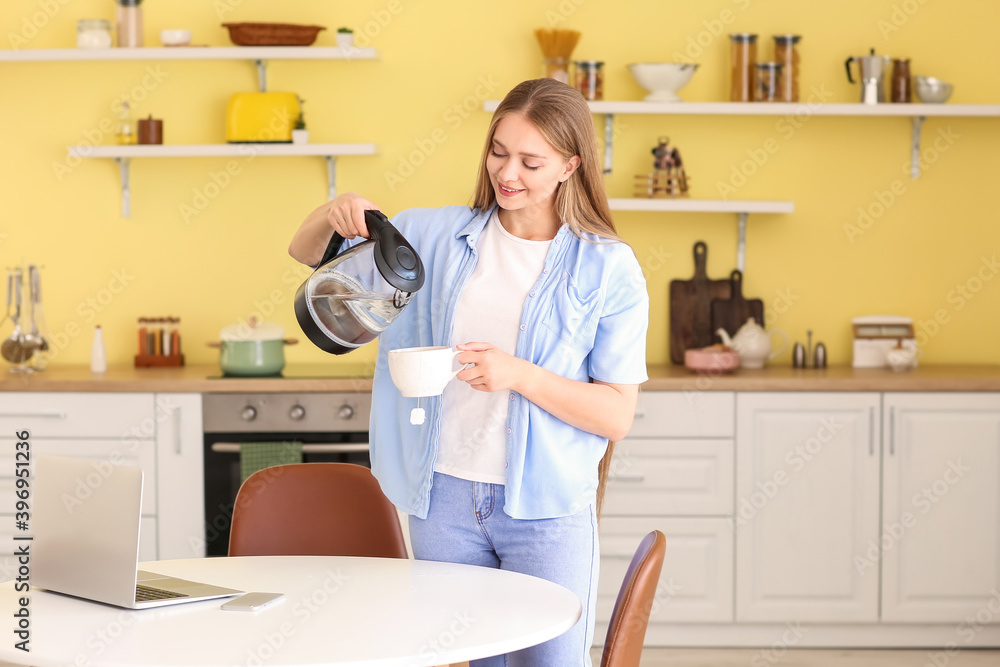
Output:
[156, 394, 205, 560]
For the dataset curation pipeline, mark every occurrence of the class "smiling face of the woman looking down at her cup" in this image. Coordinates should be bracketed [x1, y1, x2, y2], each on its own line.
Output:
[486, 114, 580, 232]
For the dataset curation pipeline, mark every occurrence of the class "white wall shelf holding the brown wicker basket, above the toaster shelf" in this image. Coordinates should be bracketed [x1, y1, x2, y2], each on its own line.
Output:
[0, 46, 377, 92]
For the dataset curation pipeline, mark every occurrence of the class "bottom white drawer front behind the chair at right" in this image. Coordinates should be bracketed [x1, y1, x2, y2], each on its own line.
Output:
[594, 516, 733, 646]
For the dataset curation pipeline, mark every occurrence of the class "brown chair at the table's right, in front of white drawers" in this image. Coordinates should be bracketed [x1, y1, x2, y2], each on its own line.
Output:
[601, 530, 667, 667]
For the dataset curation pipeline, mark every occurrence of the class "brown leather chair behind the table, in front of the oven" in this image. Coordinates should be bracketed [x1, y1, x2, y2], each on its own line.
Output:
[229, 463, 407, 558]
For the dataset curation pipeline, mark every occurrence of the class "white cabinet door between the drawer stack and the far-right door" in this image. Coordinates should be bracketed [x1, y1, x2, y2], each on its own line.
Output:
[734, 393, 880, 623]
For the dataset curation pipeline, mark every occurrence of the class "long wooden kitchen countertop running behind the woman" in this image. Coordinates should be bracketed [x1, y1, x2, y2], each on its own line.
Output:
[0, 364, 1000, 393]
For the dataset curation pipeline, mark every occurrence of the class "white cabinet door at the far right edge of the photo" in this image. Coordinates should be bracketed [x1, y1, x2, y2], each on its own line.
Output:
[873, 394, 1000, 623]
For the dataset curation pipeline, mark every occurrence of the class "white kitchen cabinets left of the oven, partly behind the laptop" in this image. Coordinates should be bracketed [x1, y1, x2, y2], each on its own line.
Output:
[0, 392, 204, 580]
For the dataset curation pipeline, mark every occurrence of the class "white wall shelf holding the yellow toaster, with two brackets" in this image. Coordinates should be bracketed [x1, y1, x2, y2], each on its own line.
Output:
[69, 144, 375, 218]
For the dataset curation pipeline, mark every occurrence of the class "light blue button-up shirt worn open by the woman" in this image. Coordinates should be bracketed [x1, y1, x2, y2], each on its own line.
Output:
[370, 206, 649, 519]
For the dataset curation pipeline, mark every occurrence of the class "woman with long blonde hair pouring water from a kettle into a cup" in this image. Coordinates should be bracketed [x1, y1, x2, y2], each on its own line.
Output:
[289, 79, 649, 667]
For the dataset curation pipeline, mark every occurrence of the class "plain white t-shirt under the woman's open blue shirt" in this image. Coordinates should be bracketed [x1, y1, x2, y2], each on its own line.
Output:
[434, 210, 552, 484]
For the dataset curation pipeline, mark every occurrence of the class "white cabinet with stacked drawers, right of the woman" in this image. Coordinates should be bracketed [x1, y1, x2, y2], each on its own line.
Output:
[595, 392, 734, 645]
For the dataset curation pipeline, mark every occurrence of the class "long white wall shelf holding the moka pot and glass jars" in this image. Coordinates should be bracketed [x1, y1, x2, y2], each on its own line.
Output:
[483, 100, 1000, 179]
